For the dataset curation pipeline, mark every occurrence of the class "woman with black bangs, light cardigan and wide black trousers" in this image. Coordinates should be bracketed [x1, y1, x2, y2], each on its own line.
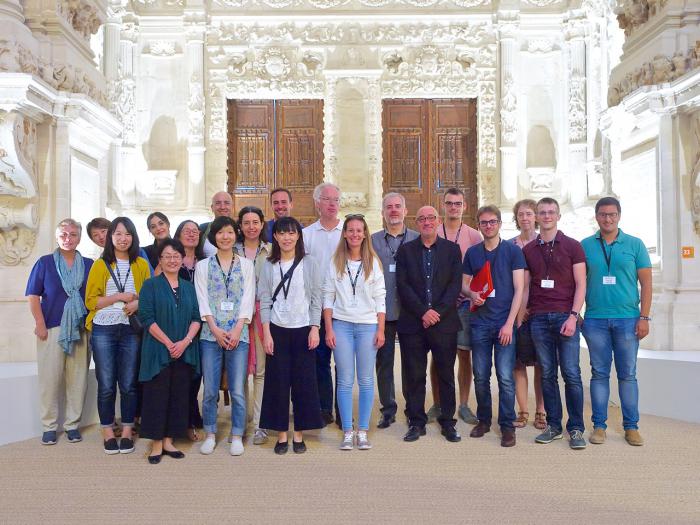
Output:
[258, 217, 323, 454]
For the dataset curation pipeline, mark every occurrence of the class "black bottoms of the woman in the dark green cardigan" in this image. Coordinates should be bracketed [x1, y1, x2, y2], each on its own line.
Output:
[140, 361, 192, 440]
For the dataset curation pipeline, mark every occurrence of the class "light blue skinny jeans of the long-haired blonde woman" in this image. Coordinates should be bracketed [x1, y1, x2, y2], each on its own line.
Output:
[333, 319, 377, 431]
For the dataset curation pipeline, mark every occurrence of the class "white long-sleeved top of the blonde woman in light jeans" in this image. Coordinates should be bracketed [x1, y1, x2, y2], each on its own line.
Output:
[323, 258, 386, 324]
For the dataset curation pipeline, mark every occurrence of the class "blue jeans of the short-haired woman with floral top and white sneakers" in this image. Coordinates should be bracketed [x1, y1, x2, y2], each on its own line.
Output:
[199, 339, 248, 436]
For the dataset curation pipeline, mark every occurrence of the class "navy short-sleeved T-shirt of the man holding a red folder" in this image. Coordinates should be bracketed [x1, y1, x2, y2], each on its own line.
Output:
[462, 241, 525, 327]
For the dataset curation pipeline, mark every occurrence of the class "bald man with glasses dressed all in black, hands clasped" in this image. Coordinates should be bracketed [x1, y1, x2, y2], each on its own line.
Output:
[396, 206, 462, 442]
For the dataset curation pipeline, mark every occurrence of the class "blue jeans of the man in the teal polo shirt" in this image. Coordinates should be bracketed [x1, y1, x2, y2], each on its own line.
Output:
[581, 318, 639, 430]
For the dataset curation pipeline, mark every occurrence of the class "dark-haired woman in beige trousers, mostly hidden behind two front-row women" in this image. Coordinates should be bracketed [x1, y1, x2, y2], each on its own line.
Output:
[234, 206, 271, 445]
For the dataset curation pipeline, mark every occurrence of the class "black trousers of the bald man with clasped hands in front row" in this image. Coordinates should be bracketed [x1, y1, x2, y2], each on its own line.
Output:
[399, 329, 457, 427]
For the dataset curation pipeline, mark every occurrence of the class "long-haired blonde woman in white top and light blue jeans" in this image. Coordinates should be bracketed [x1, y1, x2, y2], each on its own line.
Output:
[323, 215, 386, 450]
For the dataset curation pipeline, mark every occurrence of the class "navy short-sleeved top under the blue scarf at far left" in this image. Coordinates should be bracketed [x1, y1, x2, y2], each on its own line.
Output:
[24, 254, 93, 328]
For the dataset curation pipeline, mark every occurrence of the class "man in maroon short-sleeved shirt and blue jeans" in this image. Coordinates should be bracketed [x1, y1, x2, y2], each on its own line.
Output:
[520, 197, 586, 450]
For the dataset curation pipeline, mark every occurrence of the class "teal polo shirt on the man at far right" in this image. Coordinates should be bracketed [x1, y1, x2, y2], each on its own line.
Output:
[581, 230, 651, 319]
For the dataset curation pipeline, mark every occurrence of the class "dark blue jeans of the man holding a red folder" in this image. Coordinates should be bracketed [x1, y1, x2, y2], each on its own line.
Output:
[471, 324, 515, 429]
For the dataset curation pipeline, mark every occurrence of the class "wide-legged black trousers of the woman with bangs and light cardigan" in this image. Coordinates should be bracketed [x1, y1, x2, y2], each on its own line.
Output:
[260, 323, 324, 432]
